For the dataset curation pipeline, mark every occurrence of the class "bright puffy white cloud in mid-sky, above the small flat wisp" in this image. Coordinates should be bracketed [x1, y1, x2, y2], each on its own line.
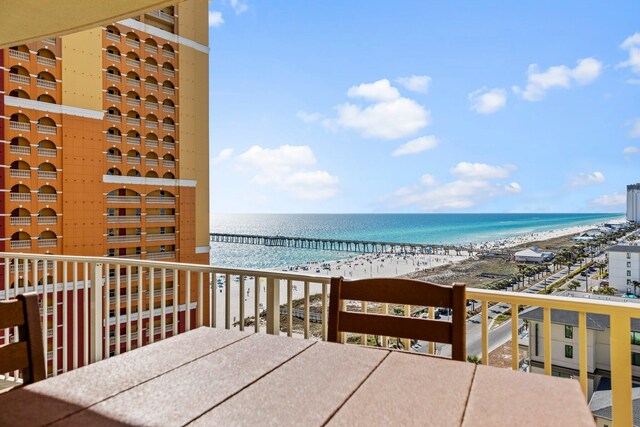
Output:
[322, 79, 431, 139]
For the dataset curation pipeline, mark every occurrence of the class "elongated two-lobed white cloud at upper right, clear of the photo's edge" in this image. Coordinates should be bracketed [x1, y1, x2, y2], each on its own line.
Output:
[512, 58, 602, 101]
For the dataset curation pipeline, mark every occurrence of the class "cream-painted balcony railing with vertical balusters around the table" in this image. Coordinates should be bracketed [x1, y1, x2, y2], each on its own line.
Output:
[0, 252, 640, 426]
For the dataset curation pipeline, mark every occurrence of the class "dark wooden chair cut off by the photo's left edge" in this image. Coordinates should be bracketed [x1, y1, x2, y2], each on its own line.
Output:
[0, 293, 47, 384]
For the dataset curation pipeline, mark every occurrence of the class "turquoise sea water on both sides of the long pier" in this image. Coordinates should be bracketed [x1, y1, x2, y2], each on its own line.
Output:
[211, 214, 622, 268]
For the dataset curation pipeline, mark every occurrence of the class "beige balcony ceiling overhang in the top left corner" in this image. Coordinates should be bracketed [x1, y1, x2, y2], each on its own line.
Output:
[0, 0, 180, 48]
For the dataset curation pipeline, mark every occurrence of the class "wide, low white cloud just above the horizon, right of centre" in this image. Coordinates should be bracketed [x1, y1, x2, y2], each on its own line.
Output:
[383, 162, 522, 211]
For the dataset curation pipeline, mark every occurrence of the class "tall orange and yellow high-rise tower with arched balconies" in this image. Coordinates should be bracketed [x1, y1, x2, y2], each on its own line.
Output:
[0, 0, 210, 369]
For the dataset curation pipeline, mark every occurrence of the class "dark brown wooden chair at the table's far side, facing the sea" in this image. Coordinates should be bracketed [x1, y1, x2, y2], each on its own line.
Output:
[328, 277, 467, 361]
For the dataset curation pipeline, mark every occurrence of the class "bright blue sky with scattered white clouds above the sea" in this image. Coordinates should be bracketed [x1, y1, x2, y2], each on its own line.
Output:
[209, 0, 640, 213]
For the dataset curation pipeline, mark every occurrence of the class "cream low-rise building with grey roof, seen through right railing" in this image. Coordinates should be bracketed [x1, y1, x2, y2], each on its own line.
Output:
[520, 304, 640, 427]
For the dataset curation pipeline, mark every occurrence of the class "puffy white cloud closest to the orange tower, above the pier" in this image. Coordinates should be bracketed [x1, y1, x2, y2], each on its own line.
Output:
[237, 145, 339, 200]
